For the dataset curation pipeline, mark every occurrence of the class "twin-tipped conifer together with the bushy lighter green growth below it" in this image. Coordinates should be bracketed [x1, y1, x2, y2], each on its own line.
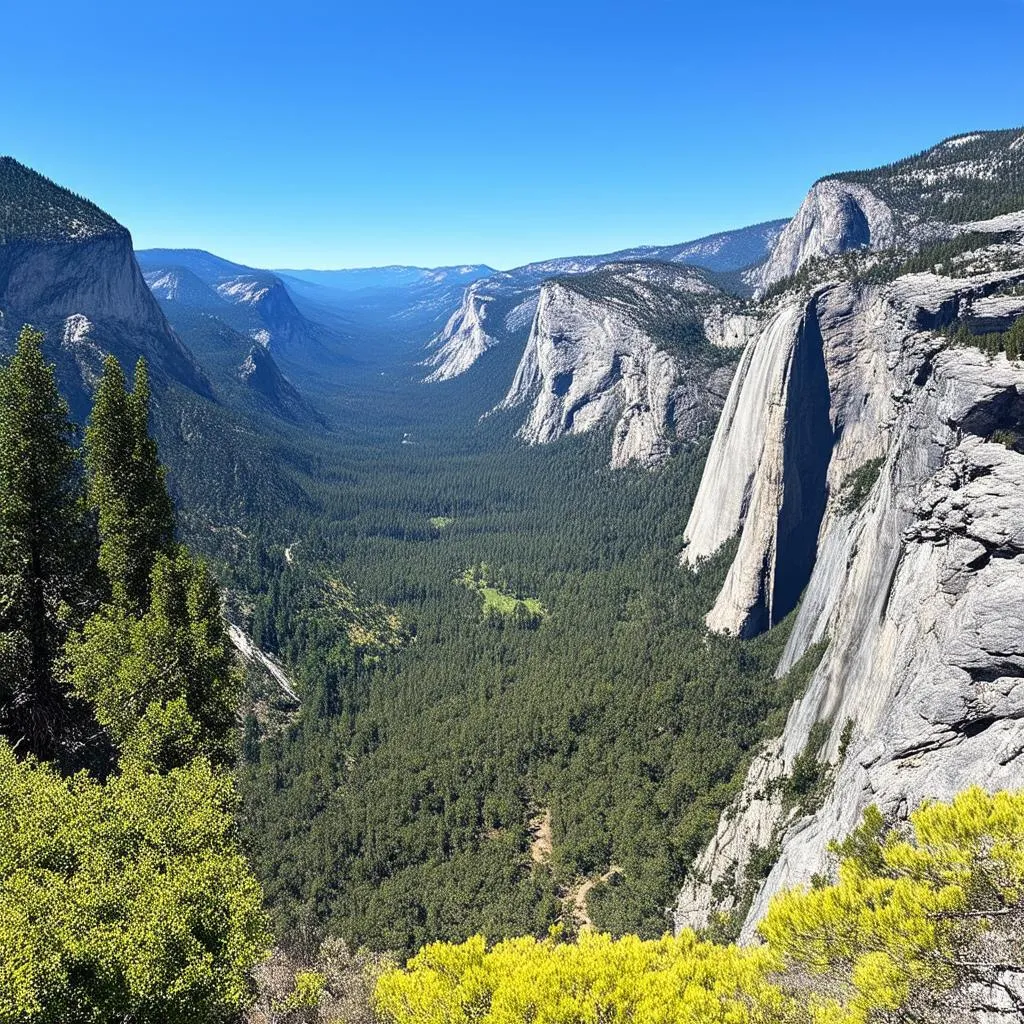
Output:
[67, 356, 238, 770]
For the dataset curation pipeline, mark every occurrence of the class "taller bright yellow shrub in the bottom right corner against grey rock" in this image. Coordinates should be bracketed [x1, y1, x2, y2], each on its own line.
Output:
[759, 787, 1024, 1024]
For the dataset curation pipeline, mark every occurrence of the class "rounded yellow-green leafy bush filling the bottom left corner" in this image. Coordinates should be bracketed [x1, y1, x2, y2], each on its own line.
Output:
[0, 741, 269, 1024]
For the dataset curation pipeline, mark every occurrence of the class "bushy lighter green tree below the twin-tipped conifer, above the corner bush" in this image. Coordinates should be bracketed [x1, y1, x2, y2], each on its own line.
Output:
[68, 548, 239, 770]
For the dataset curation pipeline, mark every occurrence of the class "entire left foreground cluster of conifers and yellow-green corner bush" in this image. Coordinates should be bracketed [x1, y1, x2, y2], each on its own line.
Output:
[0, 329, 269, 1024]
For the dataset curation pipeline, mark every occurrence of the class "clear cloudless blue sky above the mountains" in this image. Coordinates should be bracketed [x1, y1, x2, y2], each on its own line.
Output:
[0, 0, 1024, 267]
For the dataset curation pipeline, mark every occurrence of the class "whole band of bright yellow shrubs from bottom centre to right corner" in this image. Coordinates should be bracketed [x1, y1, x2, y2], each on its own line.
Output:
[376, 788, 1024, 1024]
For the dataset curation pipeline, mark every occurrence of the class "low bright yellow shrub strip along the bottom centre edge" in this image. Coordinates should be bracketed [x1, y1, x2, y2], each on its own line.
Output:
[377, 932, 786, 1024]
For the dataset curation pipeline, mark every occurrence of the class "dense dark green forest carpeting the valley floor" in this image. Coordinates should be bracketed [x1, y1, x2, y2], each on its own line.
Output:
[149, 321, 799, 951]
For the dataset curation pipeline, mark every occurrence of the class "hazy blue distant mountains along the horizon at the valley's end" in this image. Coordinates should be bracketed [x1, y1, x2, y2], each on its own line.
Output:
[137, 220, 785, 380]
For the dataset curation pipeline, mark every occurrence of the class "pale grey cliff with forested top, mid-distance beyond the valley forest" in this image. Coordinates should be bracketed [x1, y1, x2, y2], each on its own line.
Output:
[499, 263, 748, 468]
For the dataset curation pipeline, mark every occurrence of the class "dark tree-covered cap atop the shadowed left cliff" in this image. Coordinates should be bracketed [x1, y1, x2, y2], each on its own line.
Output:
[0, 157, 125, 245]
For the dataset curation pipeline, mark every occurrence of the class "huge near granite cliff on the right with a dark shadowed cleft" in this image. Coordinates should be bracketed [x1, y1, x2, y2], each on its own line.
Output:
[675, 245, 1024, 940]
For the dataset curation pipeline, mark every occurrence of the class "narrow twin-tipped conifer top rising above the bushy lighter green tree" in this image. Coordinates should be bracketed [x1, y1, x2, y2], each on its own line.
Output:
[85, 355, 174, 612]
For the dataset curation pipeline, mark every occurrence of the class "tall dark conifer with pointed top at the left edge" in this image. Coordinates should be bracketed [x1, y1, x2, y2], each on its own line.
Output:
[0, 326, 88, 758]
